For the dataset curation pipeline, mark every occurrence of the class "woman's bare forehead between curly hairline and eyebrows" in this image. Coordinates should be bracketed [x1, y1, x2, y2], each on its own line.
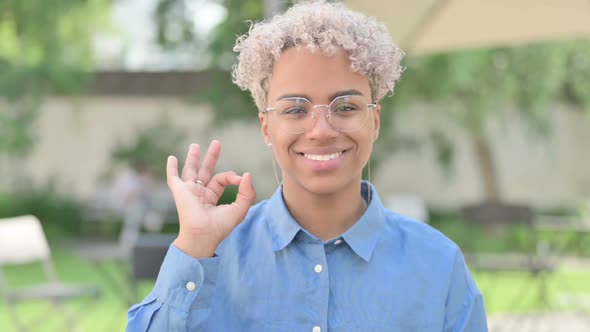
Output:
[268, 47, 370, 104]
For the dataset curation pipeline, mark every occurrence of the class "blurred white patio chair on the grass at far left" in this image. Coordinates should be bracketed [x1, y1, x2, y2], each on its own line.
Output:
[0, 215, 100, 331]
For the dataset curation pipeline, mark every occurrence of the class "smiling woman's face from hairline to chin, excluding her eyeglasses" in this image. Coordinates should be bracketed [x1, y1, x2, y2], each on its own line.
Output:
[259, 47, 381, 194]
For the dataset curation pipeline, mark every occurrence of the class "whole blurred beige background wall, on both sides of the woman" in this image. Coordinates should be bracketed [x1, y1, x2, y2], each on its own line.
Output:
[16, 96, 590, 207]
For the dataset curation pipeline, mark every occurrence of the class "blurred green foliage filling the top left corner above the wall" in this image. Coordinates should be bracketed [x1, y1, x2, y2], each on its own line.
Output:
[0, 0, 109, 155]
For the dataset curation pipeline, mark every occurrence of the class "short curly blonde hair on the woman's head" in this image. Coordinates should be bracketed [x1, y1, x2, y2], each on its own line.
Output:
[232, 0, 405, 110]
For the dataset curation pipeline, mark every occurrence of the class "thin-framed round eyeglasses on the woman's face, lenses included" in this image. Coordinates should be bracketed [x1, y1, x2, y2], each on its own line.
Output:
[264, 95, 377, 134]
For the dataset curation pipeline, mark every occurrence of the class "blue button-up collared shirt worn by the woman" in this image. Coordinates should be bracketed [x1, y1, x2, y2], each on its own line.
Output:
[127, 182, 487, 332]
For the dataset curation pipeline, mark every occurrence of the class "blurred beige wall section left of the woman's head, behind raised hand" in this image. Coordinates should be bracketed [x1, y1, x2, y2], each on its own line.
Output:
[24, 96, 276, 197]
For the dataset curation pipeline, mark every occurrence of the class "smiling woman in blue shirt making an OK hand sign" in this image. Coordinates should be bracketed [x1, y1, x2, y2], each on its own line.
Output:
[128, 1, 487, 332]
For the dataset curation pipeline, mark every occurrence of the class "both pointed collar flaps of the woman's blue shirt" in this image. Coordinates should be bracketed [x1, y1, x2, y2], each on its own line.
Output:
[267, 181, 385, 262]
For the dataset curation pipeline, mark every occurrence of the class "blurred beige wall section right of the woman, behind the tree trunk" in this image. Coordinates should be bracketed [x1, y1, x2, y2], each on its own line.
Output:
[375, 105, 590, 208]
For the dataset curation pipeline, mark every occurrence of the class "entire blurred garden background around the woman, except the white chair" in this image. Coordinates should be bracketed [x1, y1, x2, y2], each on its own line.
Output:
[0, 0, 590, 331]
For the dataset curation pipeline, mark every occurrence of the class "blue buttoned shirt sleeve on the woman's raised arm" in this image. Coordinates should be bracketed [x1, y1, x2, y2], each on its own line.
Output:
[126, 244, 220, 332]
